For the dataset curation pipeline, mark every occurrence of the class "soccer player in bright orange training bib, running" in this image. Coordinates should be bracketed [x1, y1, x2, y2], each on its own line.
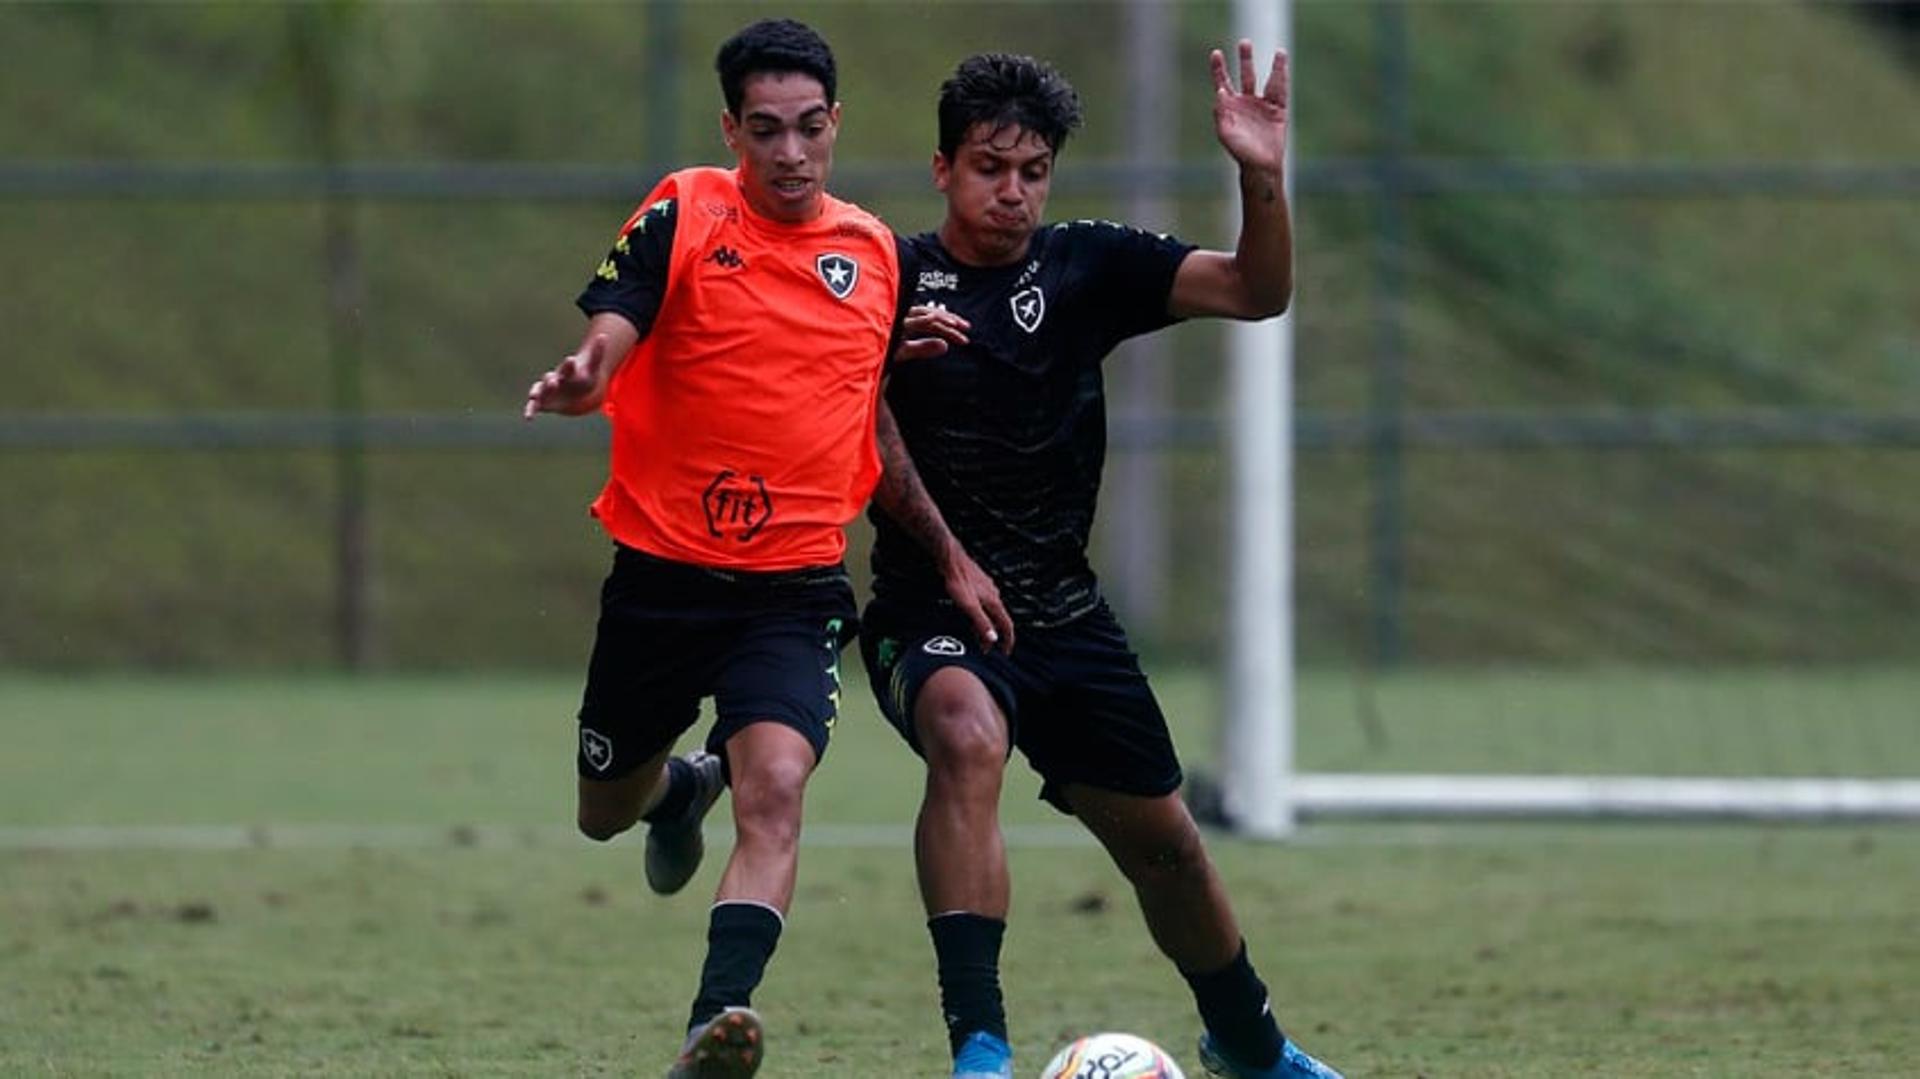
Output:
[526, 19, 910, 1079]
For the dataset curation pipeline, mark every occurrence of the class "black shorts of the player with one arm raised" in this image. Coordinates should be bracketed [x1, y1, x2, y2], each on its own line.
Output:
[860, 599, 1181, 812]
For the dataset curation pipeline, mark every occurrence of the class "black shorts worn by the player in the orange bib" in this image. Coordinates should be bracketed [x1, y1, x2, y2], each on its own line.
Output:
[578, 545, 858, 779]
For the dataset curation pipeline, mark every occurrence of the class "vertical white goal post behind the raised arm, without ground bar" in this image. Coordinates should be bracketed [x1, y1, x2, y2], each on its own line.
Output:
[1221, 0, 1298, 839]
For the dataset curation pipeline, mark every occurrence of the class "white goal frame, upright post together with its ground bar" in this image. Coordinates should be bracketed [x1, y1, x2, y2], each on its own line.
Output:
[1219, 0, 1920, 839]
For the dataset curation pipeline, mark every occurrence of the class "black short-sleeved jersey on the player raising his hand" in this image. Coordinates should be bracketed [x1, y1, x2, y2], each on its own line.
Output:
[868, 221, 1192, 626]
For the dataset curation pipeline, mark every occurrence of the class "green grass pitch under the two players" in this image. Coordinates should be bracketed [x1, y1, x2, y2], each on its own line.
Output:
[0, 676, 1920, 1079]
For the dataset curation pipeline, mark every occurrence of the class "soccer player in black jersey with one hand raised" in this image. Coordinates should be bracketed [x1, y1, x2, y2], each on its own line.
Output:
[860, 40, 1336, 1079]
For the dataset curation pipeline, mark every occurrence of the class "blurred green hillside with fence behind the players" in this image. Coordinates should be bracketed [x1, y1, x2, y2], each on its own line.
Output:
[0, 0, 1920, 670]
